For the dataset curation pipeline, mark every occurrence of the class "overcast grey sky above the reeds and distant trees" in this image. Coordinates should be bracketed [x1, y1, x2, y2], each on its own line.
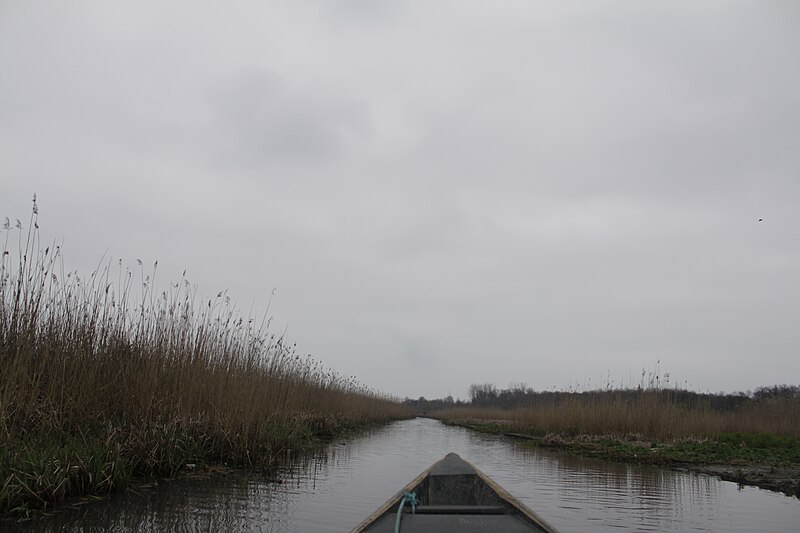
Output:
[0, 0, 800, 398]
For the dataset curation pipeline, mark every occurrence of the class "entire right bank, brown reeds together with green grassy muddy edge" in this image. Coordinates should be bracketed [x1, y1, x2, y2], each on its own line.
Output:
[431, 389, 800, 495]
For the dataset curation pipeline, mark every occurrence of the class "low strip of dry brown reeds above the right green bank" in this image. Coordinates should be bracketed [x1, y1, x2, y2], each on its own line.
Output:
[433, 389, 800, 440]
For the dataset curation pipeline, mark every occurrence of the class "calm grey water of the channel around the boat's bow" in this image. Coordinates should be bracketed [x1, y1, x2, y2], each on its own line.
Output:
[18, 419, 800, 532]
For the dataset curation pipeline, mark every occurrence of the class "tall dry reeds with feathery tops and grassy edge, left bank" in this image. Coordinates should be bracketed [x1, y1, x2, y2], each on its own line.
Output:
[0, 198, 405, 513]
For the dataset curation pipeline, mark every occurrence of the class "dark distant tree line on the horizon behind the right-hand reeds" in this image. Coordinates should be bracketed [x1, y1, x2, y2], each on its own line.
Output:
[404, 383, 800, 411]
